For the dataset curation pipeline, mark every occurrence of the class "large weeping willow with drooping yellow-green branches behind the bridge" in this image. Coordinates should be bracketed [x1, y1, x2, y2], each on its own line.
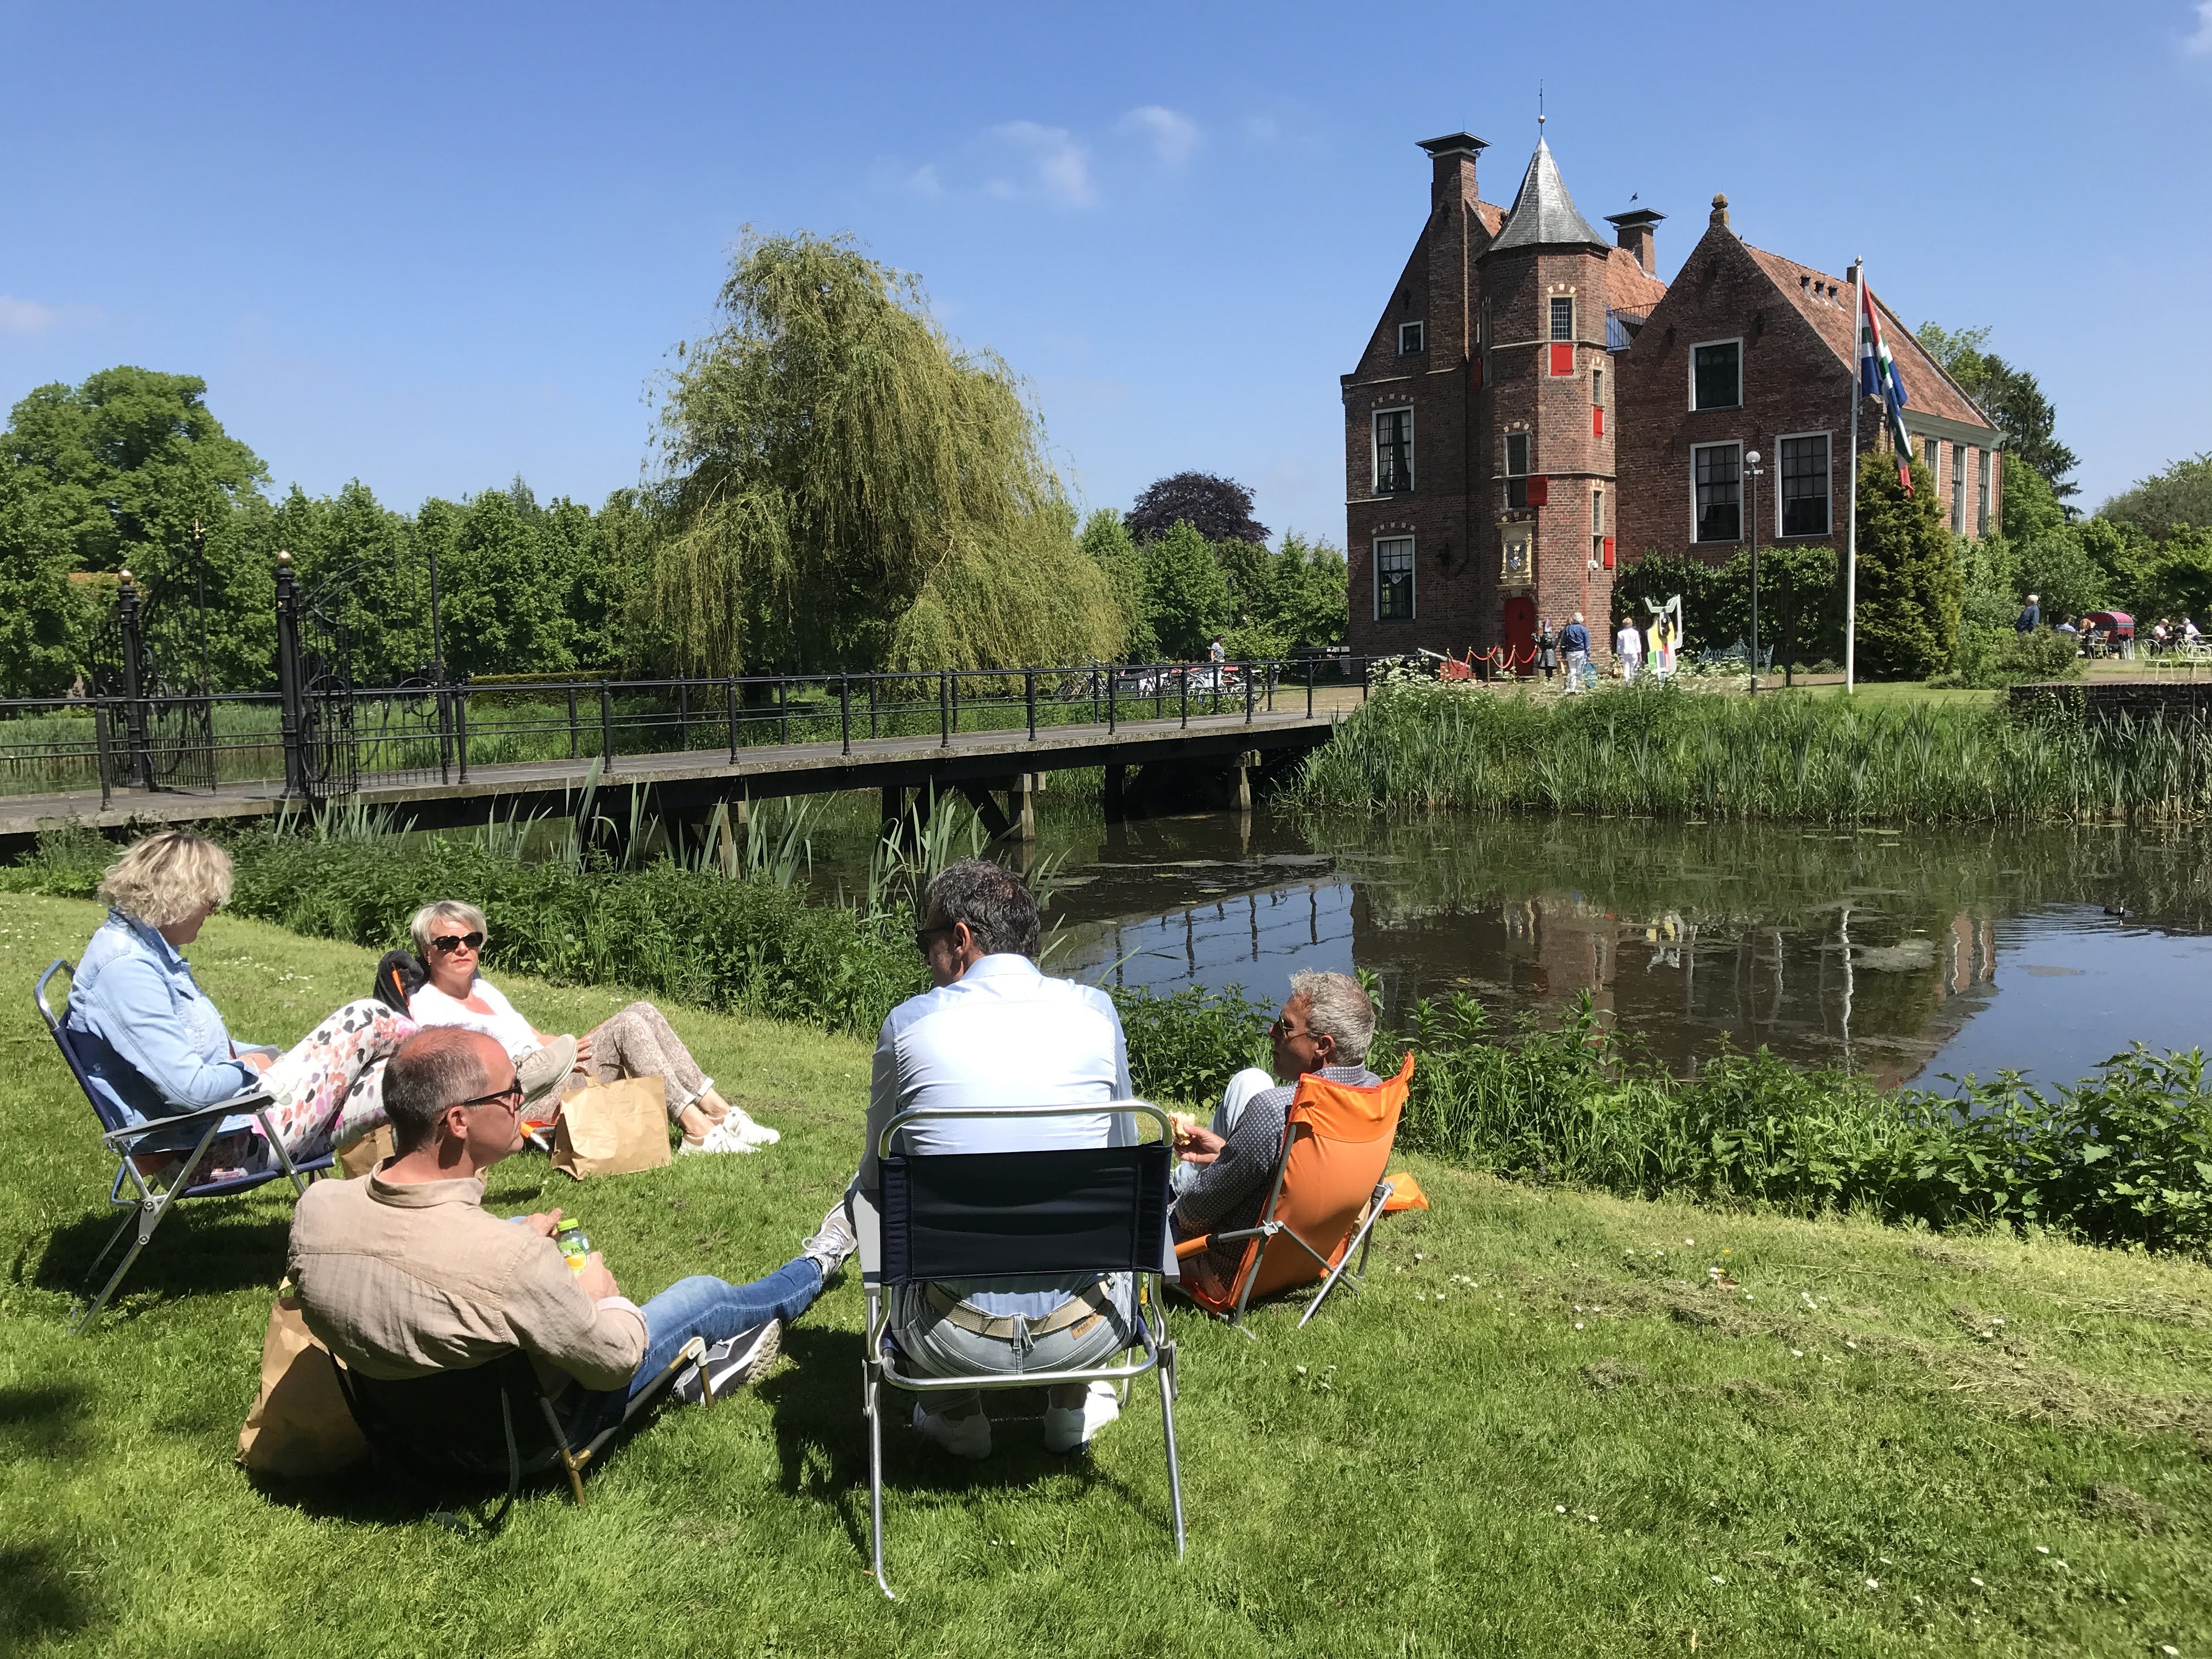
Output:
[644, 234, 1121, 673]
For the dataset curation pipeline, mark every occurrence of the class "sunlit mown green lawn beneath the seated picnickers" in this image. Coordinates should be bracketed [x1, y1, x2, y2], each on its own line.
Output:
[0, 896, 2212, 1659]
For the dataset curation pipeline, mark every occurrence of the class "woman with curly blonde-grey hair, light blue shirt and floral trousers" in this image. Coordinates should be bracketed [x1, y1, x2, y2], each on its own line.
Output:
[69, 830, 416, 1172]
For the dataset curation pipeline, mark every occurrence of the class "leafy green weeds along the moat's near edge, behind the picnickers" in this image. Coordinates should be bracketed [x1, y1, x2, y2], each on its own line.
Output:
[17, 834, 2212, 1254]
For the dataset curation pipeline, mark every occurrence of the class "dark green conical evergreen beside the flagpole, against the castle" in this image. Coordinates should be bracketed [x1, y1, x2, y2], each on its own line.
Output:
[1858, 452, 1962, 679]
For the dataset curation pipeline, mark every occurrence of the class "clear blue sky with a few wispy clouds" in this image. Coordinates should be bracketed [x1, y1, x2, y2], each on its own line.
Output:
[0, 0, 2212, 542]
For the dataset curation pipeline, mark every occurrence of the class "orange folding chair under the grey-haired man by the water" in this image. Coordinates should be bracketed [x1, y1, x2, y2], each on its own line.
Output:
[1175, 1053, 1413, 1327]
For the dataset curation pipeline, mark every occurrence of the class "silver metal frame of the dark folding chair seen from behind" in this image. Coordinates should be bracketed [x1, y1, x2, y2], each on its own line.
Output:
[851, 1099, 1183, 1599]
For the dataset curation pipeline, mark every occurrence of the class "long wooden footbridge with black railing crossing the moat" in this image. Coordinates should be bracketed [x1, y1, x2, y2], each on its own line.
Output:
[0, 664, 1365, 854]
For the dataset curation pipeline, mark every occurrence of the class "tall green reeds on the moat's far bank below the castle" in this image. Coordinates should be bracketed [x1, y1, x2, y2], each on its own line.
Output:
[1296, 679, 2212, 823]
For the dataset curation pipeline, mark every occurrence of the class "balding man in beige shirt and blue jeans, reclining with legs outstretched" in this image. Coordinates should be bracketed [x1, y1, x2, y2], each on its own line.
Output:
[290, 1026, 849, 1434]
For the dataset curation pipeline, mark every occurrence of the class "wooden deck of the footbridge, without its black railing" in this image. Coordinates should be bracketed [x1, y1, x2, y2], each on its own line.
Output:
[0, 708, 1342, 849]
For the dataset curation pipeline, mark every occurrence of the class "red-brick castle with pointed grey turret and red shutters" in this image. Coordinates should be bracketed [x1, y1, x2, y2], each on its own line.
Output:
[1342, 133, 2000, 654]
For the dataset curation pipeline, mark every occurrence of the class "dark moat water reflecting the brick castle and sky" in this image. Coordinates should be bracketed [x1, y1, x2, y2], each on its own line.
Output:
[1046, 814, 2212, 1082]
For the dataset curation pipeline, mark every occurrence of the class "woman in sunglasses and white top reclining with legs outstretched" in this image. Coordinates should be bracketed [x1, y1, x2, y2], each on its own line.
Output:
[407, 898, 783, 1153]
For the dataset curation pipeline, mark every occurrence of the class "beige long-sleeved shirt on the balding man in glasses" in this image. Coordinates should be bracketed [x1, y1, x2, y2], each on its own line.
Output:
[290, 1175, 646, 1389]
